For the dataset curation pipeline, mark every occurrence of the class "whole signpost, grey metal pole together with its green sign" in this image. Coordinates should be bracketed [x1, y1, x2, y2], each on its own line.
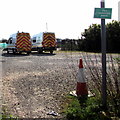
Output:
[94, 0, 112, 110]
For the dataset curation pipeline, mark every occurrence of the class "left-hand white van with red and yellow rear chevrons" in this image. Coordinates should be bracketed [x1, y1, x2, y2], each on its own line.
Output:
[3, 32, 32, 54]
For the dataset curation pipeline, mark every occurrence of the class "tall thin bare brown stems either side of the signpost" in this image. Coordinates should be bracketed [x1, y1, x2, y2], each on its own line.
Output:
[82, 53, 120, 117]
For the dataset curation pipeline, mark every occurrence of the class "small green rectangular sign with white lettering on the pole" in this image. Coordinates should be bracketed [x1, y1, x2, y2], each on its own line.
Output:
[94, 8, 112, 19]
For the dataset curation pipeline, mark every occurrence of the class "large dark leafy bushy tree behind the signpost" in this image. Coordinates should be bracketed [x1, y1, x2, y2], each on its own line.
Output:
[82, 21, 120, 53]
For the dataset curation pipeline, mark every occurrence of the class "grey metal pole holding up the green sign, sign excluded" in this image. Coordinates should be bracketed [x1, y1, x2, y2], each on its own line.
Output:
[101, 0, 107, 110]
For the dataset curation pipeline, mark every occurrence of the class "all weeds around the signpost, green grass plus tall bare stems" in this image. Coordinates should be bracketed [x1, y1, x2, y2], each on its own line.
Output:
[63, 53, 120, 120]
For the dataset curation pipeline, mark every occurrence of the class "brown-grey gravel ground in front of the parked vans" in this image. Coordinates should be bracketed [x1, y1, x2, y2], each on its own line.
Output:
[1, 53, 80, 118]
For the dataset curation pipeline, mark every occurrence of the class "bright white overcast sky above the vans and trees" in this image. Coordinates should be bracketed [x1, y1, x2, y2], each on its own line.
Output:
[0, 0, 120, 39]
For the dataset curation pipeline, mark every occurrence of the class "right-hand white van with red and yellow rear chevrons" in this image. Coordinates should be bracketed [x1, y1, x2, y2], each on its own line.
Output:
[32, 32, 56, 54]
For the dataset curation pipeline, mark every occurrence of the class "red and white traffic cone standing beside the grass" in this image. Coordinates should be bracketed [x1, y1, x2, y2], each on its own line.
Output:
[76, 59, 88, 97]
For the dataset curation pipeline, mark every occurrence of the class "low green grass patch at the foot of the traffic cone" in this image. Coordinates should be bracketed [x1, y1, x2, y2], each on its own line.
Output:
[64, 96, 111, 120]
